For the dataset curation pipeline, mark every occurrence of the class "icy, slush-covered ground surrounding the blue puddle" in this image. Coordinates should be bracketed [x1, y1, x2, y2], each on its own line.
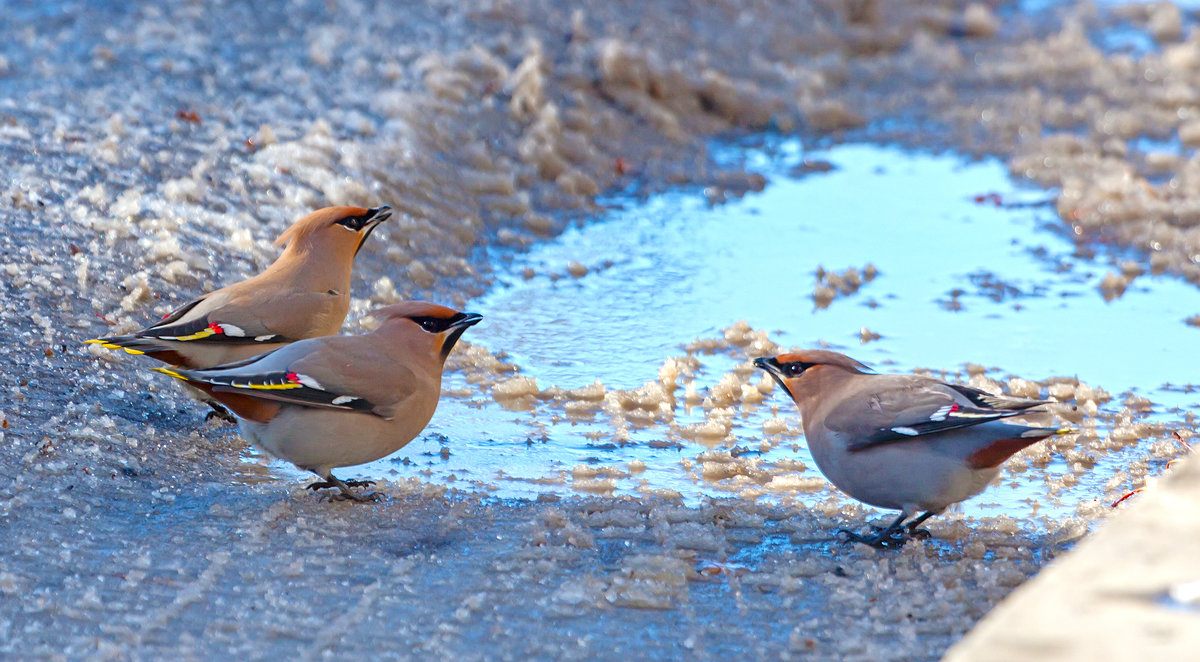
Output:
[0, 0, 1200, 660]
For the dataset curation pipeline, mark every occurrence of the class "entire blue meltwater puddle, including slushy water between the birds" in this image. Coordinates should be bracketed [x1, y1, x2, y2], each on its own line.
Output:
[267, 140, 1200, 527]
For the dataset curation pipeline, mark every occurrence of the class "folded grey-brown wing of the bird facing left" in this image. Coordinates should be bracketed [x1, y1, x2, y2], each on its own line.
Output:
[824, 375, 1044, 452]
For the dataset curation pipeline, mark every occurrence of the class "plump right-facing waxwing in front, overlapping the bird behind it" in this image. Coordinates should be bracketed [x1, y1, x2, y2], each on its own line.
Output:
[155, 301, 482, 501]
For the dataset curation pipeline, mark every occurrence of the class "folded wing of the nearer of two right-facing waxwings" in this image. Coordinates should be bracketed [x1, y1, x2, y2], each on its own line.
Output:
[154, 336, 416, 419]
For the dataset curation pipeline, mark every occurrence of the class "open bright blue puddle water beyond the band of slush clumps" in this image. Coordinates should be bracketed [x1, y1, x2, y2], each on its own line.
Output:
[473, 145, 1200, 391]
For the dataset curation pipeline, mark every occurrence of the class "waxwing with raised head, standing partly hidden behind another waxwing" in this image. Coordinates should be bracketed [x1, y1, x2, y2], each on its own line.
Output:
[85, 205, 391, 417]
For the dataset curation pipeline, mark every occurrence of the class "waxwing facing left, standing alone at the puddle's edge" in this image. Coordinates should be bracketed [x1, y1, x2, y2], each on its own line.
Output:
[754, 350, 1072, 547]
